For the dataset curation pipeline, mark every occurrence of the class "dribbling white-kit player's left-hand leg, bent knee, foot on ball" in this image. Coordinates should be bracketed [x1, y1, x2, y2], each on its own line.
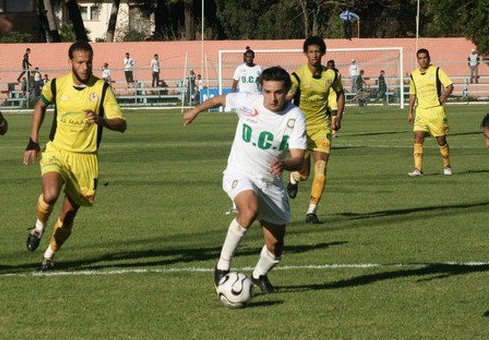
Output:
[214, 187, 258, 286]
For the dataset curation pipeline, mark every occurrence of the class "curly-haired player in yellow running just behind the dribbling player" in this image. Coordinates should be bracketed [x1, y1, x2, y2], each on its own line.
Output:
[287, 36, 345, 223]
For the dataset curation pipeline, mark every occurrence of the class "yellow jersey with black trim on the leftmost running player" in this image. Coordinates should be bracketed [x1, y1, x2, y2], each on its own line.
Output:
[41, 73, 124, 153]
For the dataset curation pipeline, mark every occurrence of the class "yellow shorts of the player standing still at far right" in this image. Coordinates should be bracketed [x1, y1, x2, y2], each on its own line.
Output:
[414, 106, 449, 137]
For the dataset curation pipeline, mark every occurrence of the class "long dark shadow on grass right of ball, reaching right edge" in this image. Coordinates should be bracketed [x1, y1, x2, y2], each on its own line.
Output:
[283, 263, 489, 291]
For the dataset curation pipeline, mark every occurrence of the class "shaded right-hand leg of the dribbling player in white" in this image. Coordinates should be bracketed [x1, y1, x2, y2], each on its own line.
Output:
[251, 220, 285, 293]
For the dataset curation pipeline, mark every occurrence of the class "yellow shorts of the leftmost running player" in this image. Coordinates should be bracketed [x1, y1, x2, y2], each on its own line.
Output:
[40, 142, 98, 206]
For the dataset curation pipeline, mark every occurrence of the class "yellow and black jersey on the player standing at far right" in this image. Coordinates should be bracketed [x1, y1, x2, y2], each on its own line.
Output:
[409, 65, 453, 109]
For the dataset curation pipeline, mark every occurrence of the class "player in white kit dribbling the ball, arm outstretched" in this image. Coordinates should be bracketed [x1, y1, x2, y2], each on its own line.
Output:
[184, 67, 307, 293]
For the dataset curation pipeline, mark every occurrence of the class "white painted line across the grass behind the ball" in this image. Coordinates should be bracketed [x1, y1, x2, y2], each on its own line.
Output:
[0, 262, 489, 278]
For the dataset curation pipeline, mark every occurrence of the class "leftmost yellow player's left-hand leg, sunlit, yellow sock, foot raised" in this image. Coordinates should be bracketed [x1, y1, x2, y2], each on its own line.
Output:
[26, 171, 64, 251]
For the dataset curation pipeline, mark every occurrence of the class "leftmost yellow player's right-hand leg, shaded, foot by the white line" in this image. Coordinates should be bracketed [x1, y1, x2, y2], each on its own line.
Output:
[40, 195, 80, 271]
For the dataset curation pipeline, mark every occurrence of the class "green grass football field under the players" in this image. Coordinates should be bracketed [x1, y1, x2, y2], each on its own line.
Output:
[0, 106, 489, 339]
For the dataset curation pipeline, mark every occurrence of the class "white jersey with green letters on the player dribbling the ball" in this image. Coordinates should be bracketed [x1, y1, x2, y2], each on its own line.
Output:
[226, 92, 307, 181]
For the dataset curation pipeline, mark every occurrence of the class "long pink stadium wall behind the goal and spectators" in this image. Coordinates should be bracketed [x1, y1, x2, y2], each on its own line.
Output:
[0, 38, 480, 83]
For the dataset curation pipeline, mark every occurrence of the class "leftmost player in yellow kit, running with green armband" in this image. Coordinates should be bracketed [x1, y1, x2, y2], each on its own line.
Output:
[24, 42, 127, 271]
